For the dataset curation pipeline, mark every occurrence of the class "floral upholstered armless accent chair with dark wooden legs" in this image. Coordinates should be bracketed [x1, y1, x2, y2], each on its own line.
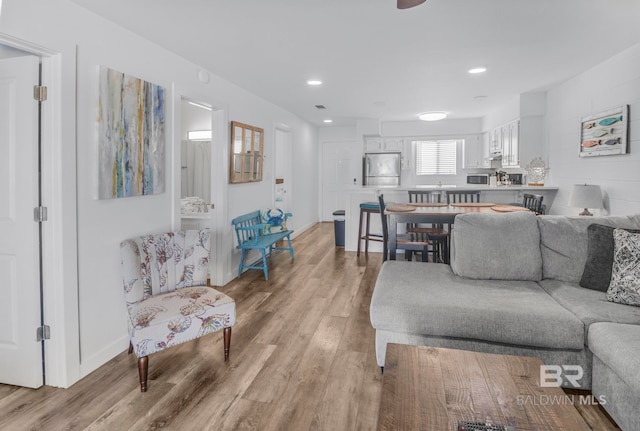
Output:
[120, 230, 236, 392]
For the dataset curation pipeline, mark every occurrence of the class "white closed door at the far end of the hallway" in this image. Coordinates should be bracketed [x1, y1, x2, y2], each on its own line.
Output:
[322, 141, 362, 221]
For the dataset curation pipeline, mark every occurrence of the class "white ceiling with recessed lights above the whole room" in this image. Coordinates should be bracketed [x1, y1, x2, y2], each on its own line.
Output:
[72, 0, 640, 125]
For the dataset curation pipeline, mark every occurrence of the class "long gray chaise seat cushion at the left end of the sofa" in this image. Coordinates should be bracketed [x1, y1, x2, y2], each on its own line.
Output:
[370, 261, 584, 350]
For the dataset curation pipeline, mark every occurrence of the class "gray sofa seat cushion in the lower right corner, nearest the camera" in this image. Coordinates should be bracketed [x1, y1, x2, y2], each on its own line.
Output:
[589, 322, 640, 392]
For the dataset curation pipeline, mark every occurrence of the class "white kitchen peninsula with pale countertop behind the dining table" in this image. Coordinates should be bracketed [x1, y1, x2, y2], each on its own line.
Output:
[344, 185, 558, 252]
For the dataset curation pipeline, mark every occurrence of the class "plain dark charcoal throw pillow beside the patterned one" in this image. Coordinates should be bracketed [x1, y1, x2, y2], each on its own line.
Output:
[580, 223, 640, 292]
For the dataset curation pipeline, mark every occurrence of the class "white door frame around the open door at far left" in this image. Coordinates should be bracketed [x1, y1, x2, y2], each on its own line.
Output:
[0, 33, 80, 387]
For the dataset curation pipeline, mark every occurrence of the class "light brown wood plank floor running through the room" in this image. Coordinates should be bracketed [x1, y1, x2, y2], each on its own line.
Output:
[0, 223, 615, 431]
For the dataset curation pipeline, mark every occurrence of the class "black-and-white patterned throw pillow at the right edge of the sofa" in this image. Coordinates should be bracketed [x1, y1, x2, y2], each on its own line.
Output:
[607, 229, 640, 306]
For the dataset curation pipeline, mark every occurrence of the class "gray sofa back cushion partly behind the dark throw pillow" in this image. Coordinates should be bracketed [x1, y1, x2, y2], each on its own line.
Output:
[536, 214, 640, 283]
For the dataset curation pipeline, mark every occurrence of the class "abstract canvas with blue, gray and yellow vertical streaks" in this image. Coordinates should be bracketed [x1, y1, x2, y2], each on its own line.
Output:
[98, 67, 166, 199]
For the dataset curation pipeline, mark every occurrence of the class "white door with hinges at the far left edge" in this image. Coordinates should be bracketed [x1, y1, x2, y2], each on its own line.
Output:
[0, 56, 43, 388]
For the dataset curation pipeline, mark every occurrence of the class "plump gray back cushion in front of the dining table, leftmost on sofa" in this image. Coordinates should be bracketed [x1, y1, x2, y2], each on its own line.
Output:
[451, 212, 542, 281]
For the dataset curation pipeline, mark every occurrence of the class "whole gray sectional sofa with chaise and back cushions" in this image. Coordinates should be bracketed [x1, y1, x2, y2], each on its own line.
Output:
[370, 212, 640, 430]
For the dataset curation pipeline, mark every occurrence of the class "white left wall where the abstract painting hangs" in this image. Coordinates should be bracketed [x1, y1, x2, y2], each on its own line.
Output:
[0, 0, 318, 386]
